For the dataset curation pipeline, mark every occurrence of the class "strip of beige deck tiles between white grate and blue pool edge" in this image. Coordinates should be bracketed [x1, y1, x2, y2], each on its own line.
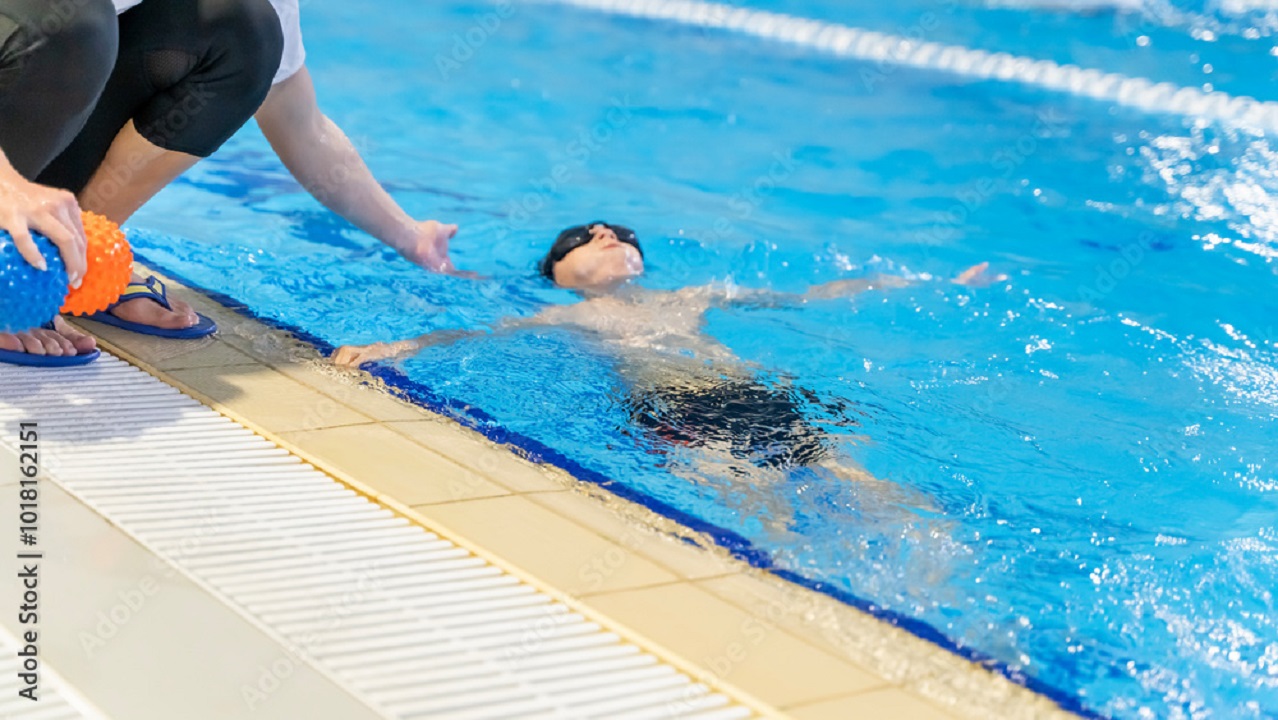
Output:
[69, 266, 1072, 720]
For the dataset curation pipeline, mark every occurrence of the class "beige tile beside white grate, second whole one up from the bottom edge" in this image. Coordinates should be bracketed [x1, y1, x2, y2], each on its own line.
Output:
[415, 495, 677, 596]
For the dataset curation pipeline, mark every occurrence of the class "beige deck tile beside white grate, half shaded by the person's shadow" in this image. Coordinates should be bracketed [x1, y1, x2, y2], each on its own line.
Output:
[169, 364, 371, 432]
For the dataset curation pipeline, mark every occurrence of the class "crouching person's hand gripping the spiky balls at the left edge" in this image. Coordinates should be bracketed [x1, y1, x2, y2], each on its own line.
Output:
[0, 162, 88, 288]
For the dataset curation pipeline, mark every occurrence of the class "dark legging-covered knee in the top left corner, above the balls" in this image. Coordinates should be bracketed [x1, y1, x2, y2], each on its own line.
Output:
[0, 0, 119, 179]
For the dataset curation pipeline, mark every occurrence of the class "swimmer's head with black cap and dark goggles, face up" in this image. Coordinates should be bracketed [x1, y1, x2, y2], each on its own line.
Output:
[541, 221, 643, 289]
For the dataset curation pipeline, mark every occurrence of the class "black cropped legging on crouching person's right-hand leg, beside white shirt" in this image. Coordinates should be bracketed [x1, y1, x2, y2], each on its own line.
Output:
[38, 0, 284, 193]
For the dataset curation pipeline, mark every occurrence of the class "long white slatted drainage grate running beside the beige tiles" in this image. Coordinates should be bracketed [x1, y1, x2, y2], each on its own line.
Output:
[0, 354, 753, 720]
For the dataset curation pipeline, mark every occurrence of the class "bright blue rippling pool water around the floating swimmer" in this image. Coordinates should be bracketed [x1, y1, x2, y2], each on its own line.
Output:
[133, 0, 1278, 717]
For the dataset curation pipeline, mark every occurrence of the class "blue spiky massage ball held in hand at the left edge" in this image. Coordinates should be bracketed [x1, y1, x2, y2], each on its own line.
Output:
[0, 230, 68, 333]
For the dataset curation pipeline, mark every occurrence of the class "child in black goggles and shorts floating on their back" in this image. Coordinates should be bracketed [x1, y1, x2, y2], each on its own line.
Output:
[334, 223, 1006, 488]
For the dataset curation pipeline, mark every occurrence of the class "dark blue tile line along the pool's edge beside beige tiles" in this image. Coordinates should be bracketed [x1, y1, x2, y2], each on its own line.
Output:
[134, 248, 1109, 720]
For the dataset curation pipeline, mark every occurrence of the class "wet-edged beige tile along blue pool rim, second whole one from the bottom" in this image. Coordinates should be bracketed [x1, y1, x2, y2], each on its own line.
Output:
[529, 491, 748, 579]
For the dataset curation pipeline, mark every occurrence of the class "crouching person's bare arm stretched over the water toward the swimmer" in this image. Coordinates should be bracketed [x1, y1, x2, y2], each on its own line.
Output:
[257, 67, 458, 272]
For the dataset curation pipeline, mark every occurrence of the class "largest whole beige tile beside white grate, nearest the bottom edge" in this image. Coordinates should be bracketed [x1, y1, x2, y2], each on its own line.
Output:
[589, 583, 886, 707]
